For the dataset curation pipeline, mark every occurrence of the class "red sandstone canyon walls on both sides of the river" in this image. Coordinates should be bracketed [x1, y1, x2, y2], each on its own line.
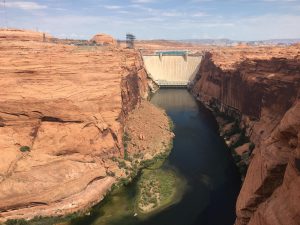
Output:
[0, 29, 300, 225]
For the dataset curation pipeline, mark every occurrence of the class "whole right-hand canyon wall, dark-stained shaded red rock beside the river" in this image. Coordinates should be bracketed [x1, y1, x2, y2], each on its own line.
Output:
[191, 46, 300, 225]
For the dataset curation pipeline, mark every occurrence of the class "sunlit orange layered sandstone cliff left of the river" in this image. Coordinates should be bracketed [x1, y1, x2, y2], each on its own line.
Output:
[0, 31, 172, 221]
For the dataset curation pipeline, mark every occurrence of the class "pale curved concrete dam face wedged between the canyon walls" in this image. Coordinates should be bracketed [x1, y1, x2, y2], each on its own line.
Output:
[143, 54, 202, 86]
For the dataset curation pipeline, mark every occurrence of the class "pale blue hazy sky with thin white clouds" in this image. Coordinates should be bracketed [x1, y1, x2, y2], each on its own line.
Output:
[0, 0, 300, 40]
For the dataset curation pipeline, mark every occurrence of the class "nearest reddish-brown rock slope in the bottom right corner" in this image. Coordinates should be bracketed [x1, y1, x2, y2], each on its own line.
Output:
[245, 100, 300, 225]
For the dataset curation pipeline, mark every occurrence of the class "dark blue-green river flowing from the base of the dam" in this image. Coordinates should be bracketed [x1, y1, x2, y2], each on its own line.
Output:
[72, 89, 241, 225]
